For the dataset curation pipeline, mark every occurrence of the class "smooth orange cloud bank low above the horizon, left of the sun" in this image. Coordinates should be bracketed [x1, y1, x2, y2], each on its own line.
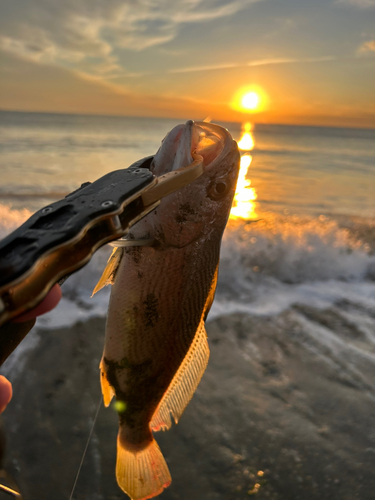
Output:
[0, 50, 215, 119]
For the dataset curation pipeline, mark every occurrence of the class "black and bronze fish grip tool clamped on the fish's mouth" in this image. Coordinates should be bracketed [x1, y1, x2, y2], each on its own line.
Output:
[0, 155, 203, 336]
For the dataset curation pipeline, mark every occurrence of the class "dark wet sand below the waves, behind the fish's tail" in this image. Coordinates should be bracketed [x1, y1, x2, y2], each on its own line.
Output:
[2, 306, 375, 500]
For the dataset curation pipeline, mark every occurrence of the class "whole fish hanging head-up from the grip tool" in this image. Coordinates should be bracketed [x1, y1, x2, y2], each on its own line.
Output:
[94, 120, 240, 500]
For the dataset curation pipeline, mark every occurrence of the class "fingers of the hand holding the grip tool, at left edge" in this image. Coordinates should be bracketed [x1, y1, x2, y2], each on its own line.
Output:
[0, 284, 62, 413]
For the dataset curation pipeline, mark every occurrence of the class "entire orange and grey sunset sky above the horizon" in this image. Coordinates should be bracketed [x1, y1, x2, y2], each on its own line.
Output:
[0, 0, 375, 127]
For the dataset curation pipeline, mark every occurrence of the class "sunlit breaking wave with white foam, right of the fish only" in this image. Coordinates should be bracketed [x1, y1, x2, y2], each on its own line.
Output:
[208, 214, 375, 319]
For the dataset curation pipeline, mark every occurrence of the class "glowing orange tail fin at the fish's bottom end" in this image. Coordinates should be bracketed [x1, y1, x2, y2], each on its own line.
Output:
[116, 437, 172, 500]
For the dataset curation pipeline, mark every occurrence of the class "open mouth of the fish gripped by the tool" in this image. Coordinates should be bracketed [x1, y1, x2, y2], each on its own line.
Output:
[151, 120, 233, 176]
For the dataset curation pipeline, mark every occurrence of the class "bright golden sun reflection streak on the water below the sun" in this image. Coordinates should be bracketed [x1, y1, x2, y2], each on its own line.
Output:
[230, 123, 258, 220]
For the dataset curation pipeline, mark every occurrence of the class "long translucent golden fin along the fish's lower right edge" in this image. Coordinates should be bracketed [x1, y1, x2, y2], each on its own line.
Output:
[150, 320, 210, 431]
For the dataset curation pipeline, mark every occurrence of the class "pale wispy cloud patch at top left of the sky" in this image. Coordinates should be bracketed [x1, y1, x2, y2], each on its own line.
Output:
[0, 0, 259, 78]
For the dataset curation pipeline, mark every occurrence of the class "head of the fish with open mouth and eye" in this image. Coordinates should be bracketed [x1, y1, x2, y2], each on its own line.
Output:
[132, 120, 240, 247]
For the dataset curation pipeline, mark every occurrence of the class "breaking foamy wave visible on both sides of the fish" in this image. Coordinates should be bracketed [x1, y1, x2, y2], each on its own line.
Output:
[0, 205, 375, 328]
